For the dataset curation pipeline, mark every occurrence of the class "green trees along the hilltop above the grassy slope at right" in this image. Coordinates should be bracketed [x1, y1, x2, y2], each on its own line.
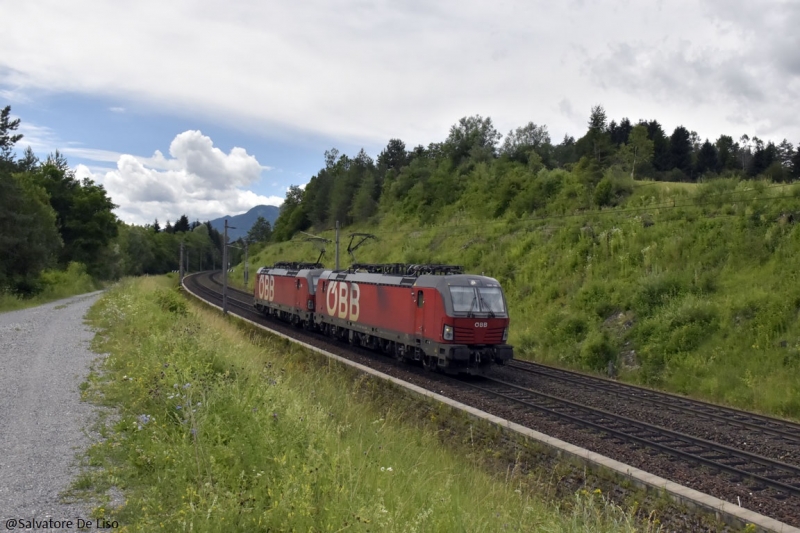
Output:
[273, 105, 800, 241]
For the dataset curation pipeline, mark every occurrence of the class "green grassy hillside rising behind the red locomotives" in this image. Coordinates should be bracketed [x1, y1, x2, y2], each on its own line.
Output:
[232, 180, 800, 418]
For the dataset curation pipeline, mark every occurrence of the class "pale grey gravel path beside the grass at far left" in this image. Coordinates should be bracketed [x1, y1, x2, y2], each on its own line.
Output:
[0, 292, 101, 529]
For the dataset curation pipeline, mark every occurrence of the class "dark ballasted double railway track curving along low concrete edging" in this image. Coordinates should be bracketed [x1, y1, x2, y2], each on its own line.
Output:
[183, 274, 800, 526]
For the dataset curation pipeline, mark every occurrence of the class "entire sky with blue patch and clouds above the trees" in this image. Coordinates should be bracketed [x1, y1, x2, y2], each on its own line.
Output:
[0, 0, 800, 224]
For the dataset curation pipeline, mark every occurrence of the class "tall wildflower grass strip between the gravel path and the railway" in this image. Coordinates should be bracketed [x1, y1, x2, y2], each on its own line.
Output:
[76, 278, 648, 532]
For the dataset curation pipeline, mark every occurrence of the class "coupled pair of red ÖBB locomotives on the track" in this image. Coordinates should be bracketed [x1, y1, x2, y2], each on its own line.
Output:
[254, 263, 513, 374]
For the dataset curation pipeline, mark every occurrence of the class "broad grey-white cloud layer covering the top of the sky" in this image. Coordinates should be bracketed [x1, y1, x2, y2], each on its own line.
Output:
[0, 0, 800, 152]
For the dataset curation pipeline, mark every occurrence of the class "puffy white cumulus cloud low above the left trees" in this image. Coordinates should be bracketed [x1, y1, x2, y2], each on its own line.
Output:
[75, 130, 283, 224]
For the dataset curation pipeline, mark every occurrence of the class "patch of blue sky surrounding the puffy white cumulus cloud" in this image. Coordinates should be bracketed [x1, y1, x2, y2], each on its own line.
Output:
[9, 92, 382, 223]
